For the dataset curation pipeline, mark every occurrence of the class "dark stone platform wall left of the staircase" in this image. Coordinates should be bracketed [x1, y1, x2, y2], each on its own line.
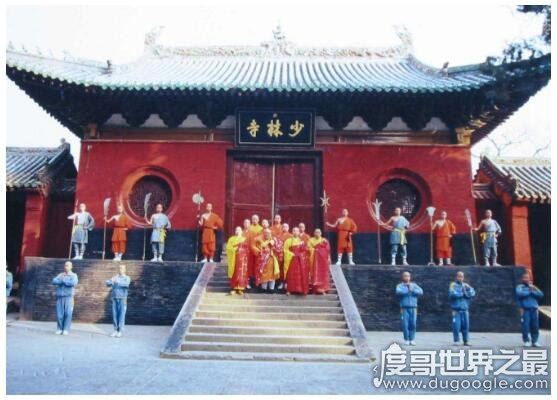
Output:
[21, 257, 202, 325]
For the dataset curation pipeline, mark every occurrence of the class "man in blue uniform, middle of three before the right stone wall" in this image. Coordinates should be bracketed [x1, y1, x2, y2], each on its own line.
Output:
[449, 271, 476, 346]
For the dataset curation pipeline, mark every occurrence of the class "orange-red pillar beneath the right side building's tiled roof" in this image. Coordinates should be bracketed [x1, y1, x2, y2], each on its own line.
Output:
[507, 204, 532, 270]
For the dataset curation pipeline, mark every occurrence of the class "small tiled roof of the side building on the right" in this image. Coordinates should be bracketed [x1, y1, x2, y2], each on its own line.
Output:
[479, 157, 551, 204]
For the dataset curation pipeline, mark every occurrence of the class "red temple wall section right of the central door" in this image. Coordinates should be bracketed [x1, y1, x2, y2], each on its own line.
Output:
[319, 144, 475, 233]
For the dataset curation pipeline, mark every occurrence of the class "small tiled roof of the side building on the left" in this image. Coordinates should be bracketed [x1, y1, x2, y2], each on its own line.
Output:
[6, 143, 75, 195]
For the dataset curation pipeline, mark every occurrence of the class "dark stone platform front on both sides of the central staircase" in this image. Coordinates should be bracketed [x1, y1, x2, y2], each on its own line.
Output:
[20, 257, 523, 332]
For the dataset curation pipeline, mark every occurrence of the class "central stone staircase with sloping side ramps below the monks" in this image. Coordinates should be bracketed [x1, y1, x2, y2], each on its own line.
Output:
[161, 264, 372, 362]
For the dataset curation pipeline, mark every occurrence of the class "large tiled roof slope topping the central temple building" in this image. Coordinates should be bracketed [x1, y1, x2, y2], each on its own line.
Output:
[6, 34, 494, 93]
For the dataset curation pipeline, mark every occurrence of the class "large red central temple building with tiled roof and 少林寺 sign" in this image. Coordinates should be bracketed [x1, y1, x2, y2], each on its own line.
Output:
[6, 31, 551, 264]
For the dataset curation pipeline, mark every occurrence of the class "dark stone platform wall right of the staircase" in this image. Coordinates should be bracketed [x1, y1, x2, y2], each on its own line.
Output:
[343, 265, 524, 332]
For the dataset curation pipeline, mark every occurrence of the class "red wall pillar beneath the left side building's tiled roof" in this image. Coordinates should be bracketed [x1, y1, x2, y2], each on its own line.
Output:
[19, 192, 48, 272]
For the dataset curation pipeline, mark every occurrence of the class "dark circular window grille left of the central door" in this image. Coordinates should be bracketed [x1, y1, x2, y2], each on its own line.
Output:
[128, 176, 172, 218]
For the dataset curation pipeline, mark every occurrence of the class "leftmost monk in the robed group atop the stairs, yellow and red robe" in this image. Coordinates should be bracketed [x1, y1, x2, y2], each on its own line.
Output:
[226, 226, 249, 294]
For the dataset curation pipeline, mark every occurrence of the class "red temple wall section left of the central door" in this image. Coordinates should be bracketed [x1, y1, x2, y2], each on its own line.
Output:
[76, 141, 229, 229]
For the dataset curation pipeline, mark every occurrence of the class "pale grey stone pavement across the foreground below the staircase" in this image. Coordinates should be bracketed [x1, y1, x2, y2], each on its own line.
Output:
[6, 316, 549, 394]
